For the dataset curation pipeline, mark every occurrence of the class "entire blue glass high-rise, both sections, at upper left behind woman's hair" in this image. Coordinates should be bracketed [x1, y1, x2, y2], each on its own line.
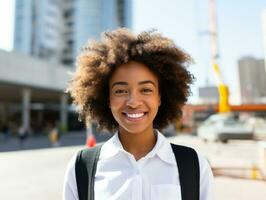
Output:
[14, 0, 132, 65]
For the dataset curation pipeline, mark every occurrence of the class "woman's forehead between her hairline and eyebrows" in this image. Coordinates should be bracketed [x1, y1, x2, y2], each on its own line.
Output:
[110, 61, 158, 84]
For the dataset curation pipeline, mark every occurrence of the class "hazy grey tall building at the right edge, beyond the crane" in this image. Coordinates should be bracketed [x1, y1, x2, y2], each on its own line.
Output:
[238, 57, 266, 103]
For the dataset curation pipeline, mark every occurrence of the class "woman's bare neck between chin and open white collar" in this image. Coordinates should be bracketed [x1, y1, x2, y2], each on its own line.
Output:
[119, 129, 157, 160]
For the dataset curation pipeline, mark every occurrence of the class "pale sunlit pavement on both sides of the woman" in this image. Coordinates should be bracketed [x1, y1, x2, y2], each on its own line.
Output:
[0, 133, 266, 200]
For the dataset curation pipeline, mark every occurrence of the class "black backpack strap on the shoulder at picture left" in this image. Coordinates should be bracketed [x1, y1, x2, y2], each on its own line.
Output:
[75, 145, 102, 200]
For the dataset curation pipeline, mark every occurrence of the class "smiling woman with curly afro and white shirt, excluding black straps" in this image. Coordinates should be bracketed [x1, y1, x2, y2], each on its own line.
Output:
[64, 29, 213, 200]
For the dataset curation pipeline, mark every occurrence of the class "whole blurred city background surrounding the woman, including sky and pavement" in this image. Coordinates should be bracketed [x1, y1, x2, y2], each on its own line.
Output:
[0, 0, 266, 200]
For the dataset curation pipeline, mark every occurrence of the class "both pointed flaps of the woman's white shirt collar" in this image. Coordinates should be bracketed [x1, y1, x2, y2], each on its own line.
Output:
[100, 130, 176, 164]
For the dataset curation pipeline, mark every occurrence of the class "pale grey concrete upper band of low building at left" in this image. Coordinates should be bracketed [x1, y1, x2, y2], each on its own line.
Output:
[0, 50, 74, 91]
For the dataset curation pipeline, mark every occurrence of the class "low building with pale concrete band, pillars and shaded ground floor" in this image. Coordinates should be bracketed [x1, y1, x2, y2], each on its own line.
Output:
[0, 51, 83, 133]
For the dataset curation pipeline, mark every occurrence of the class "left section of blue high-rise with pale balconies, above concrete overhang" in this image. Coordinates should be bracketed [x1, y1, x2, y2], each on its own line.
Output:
[14, 0, 63, 62]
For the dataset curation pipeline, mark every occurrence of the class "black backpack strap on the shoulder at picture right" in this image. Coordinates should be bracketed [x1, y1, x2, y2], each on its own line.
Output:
[171, 144, 200, 200]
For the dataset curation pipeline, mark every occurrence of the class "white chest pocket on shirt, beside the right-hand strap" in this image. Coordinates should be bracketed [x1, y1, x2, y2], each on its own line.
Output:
[151, 184, 181, 200]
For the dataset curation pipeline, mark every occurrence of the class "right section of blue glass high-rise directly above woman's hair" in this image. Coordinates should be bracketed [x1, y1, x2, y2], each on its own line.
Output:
[74, 0, 132, 61]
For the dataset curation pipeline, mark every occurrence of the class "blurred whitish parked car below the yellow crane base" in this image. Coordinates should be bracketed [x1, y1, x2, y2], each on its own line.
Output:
[197, 113, 253, 142]
